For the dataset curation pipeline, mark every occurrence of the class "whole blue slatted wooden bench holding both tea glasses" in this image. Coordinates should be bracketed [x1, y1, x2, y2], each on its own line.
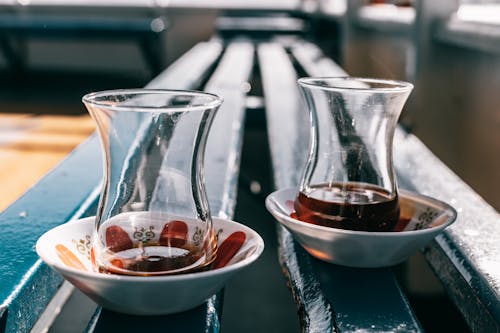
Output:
[0, 33, 500, 332]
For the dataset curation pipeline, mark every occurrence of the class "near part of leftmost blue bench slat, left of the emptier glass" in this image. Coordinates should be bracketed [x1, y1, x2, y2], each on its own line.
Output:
[0, 136, 101, 332]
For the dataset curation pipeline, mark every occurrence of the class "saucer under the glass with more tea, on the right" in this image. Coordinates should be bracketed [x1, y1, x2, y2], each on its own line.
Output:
[266, 189, 457, 268]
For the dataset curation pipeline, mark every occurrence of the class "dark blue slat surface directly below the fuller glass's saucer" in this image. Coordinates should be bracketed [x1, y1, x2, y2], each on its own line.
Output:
[311, 257, 421, 332]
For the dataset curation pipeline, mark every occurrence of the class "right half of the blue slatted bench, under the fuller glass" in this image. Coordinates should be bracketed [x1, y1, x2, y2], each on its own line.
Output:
[258, 37, 500, 332]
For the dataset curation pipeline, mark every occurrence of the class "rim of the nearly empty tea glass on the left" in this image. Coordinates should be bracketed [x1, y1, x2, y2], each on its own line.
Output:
[82, 88, 223, 113]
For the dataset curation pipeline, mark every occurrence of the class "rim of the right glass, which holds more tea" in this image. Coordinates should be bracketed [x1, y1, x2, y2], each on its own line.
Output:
[297, 76, 413, 93]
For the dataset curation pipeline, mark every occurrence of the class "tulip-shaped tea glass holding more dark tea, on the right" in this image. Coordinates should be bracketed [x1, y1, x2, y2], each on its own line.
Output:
[294, 77, 413, 231]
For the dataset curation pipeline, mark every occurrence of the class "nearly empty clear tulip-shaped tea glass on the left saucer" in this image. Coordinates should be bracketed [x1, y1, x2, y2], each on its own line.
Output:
[82, 89, 222, 276]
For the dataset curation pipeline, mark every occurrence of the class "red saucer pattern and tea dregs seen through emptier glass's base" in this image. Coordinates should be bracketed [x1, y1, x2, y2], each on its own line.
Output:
[94, 213, 217, 276]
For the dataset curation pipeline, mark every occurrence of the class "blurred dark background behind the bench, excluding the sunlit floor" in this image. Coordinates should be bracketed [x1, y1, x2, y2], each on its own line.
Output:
[0, 0, 500, 209]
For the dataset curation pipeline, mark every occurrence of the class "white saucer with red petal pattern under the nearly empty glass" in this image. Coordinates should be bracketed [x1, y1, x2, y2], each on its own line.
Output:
[36, 217, 264, 315]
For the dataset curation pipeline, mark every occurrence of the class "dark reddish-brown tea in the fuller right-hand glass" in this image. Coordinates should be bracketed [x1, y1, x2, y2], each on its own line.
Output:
[293, 183, 399, 231]
